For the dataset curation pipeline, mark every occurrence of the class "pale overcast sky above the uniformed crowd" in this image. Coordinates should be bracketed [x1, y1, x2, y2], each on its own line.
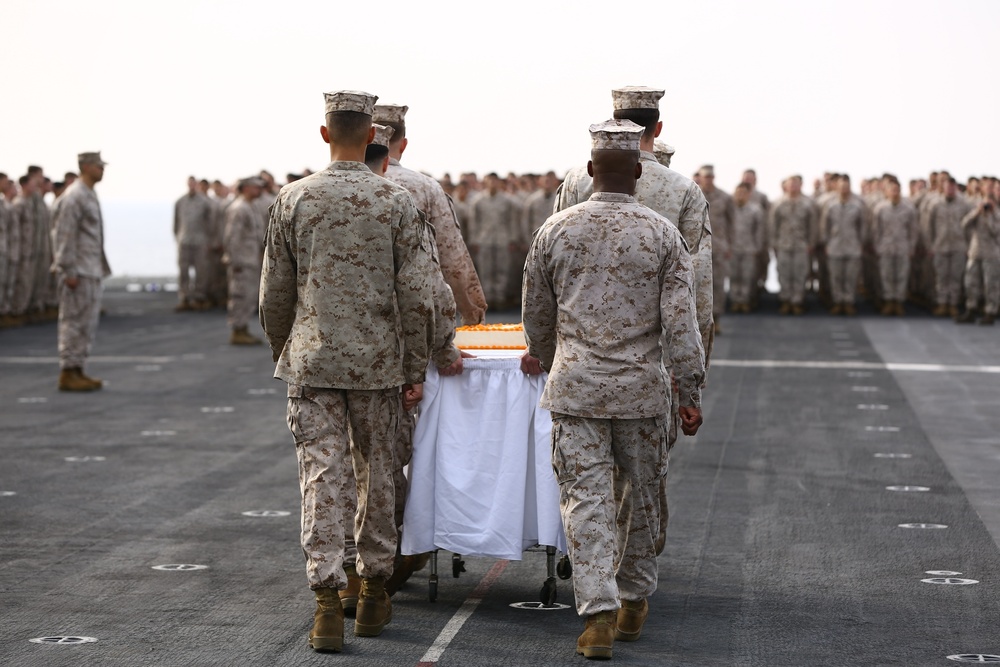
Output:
[0, 0, 1000, 274]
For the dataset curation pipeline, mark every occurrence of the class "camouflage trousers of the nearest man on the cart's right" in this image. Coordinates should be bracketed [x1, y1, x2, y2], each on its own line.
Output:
[552, 412, 668, 616]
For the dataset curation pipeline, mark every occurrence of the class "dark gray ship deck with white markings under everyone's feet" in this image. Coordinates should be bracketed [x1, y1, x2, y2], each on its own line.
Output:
[0, 289, 1000, 667]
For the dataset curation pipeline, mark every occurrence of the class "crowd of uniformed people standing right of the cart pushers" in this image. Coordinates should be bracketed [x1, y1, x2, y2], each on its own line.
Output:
[695, 167, 1000, 325]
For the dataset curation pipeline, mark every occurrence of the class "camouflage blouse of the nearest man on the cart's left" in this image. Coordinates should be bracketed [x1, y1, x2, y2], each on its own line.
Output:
[260, 162, 436, 390]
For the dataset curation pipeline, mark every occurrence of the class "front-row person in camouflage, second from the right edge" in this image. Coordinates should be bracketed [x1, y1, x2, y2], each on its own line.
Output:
[925, 178, 972, 317]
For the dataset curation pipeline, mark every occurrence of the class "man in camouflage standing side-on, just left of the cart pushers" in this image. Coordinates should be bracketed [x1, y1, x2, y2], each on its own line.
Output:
[222, 177, 264, 345]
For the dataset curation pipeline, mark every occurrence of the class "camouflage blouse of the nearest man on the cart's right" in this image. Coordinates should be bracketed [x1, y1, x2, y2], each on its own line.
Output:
[523, 192, 705, 419]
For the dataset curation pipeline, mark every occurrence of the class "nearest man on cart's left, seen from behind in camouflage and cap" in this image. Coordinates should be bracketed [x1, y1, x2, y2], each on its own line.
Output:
[260, 91, 434, 651]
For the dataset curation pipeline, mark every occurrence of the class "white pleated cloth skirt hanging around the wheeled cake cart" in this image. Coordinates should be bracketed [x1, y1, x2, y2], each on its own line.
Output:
[401, 350, 566, 560]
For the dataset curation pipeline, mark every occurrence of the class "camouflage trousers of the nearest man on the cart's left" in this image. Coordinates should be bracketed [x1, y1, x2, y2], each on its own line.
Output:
[287, 385, 400, 589]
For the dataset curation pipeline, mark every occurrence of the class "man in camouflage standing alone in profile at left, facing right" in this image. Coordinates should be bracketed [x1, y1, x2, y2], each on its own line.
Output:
[52, 153, 111, 391]
